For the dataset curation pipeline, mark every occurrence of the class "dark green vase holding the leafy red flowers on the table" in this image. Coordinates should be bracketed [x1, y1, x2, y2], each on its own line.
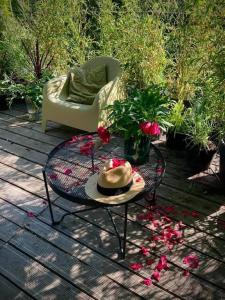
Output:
[124, 136, 151, 165]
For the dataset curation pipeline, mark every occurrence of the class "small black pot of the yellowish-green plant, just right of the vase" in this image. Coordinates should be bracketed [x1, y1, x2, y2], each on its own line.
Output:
[166, 129, 187, 150]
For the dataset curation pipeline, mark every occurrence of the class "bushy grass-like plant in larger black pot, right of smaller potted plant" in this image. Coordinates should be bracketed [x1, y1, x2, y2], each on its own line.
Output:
[186, 102, 217, 172]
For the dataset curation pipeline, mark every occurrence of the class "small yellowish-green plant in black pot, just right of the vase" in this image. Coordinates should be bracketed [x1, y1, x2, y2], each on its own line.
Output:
[166, 101, 187, 150]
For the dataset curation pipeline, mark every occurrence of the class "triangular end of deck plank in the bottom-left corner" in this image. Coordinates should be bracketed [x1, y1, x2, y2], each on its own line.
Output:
[0, 275, 33, 300]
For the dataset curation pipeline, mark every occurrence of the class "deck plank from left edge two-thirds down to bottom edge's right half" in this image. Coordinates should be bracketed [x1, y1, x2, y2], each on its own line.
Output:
[0, 200, 174, 299]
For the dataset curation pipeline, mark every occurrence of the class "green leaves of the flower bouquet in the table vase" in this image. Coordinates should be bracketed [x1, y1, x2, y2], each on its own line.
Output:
[106, 84, 170, 138]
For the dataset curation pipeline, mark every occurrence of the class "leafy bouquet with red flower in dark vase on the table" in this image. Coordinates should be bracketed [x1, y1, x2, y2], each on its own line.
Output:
[106, 84, 170, 164]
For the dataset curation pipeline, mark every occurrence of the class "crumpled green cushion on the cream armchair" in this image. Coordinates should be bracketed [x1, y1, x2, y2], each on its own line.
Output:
[66, 65, 107, 105]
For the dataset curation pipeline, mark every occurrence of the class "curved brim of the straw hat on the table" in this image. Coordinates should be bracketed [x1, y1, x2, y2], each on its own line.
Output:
[85, 172, 145, 204]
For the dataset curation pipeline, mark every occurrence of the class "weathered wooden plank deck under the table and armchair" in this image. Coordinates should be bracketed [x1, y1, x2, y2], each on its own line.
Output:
[0, 106, 225, 300]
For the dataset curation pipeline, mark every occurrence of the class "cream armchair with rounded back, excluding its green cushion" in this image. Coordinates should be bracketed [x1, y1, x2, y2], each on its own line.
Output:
[42, 56, 122, 132]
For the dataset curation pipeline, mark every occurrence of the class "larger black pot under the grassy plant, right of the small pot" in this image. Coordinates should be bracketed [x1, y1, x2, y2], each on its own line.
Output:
[187, 143, 216, 173]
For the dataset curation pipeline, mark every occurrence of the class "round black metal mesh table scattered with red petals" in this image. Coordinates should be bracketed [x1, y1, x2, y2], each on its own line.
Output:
[43, 133, 165, 258]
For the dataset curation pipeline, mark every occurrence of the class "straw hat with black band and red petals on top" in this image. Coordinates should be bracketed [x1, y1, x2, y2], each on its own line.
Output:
[85, 159, 145, 204]
